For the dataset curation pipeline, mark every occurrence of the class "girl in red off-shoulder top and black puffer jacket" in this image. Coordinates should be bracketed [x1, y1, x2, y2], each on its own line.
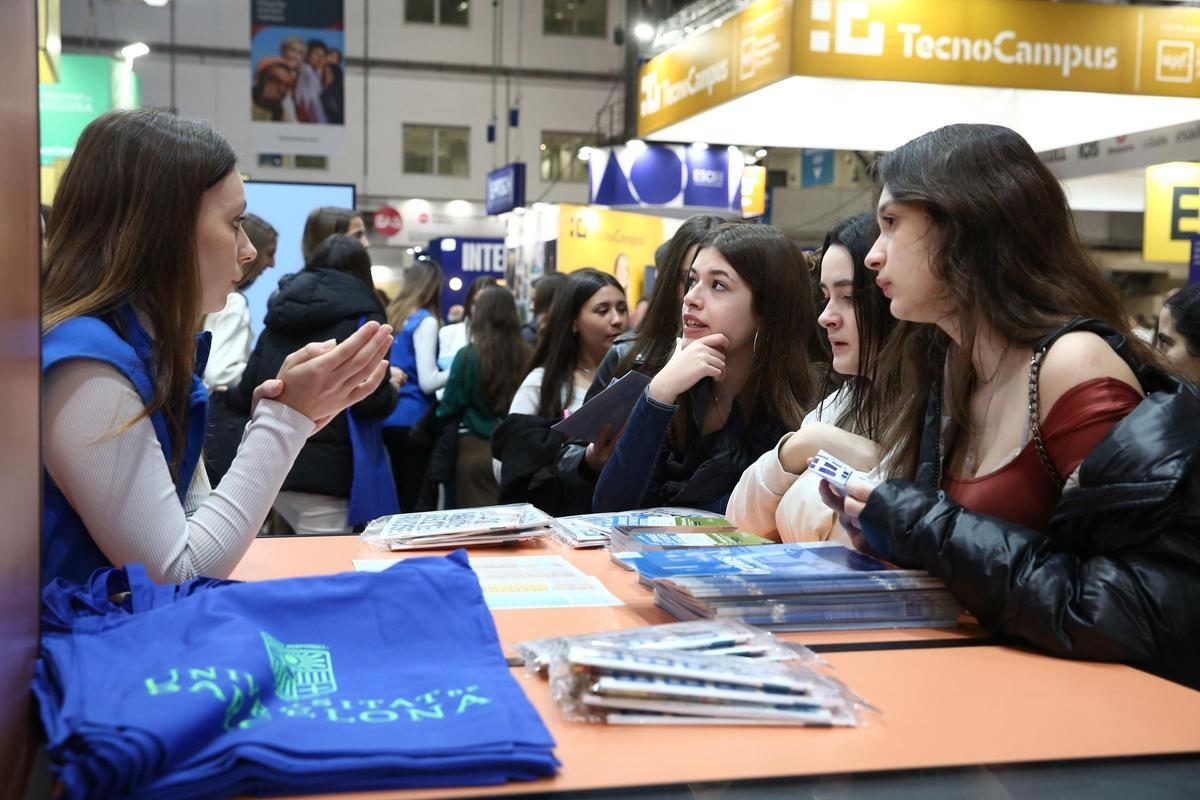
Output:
[822, 125, 1200, 686]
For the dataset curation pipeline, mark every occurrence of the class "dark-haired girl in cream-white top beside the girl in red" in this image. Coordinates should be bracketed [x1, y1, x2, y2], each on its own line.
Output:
[725, 212, 896, 545]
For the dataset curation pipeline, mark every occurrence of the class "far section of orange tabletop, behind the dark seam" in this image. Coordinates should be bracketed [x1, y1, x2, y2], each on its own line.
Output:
[230, 536, 988, 646]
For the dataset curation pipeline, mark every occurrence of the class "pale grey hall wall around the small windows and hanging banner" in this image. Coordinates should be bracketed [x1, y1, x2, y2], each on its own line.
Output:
[62, 0, 624, 203]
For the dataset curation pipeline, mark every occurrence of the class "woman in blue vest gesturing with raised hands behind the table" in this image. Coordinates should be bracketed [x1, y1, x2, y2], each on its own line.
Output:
[42, 109, 391, 582]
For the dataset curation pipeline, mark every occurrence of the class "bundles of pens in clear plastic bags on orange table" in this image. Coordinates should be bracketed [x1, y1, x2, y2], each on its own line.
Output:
[517, 621, 874, 727]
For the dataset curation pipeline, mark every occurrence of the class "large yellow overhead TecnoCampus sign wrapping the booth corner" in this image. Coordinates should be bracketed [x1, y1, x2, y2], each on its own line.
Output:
[637, 0, 1200, 134]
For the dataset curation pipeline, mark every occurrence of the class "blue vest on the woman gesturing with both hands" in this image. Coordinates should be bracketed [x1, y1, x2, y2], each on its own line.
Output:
[42, 306, 212, 585]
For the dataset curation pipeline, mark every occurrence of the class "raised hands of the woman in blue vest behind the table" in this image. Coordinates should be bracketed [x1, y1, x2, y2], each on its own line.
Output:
[276, 321, 392, 431]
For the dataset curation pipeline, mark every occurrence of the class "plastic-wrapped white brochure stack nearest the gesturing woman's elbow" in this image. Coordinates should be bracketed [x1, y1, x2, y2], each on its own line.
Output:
[362, 503, 553, 551]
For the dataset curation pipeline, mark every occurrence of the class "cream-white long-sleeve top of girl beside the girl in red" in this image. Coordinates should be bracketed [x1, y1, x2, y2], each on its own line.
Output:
[725, 386, 878, 547]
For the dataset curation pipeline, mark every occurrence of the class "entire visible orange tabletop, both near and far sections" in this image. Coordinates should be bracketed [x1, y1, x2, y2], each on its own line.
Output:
[226, 537, 1200, 798]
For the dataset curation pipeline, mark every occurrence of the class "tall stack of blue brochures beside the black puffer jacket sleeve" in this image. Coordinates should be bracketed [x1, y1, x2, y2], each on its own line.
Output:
[632, 542, 962, 631]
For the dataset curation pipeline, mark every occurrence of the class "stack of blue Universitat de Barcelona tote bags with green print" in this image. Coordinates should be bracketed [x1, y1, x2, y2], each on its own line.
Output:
[34, 551, 558, 800]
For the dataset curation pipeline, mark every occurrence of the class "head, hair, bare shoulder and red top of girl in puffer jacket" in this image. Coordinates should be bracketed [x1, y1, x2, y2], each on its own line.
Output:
[847, 125, 1153, 530]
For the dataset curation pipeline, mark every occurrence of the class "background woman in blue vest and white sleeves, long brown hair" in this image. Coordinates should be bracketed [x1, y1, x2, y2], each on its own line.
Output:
[383, 258, 450, 512]
